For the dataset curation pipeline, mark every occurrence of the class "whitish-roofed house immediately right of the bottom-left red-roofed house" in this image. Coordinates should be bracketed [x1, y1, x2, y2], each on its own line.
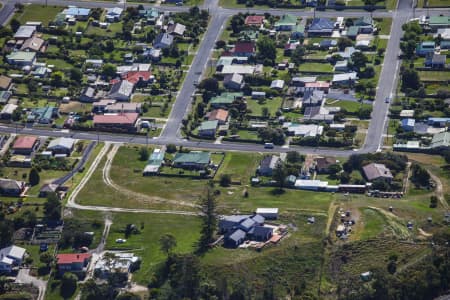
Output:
[94, 253, 140, 279]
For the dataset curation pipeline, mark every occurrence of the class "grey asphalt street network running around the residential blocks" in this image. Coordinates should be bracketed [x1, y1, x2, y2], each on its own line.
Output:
[0, 0, 450, 156]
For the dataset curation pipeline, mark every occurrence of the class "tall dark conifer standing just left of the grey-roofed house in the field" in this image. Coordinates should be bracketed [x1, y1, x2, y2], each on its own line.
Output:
[198, 185, 217, 253]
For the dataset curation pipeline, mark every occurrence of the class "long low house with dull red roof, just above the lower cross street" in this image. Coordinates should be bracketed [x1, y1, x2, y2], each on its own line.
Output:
[93, 113, 139, 132]
